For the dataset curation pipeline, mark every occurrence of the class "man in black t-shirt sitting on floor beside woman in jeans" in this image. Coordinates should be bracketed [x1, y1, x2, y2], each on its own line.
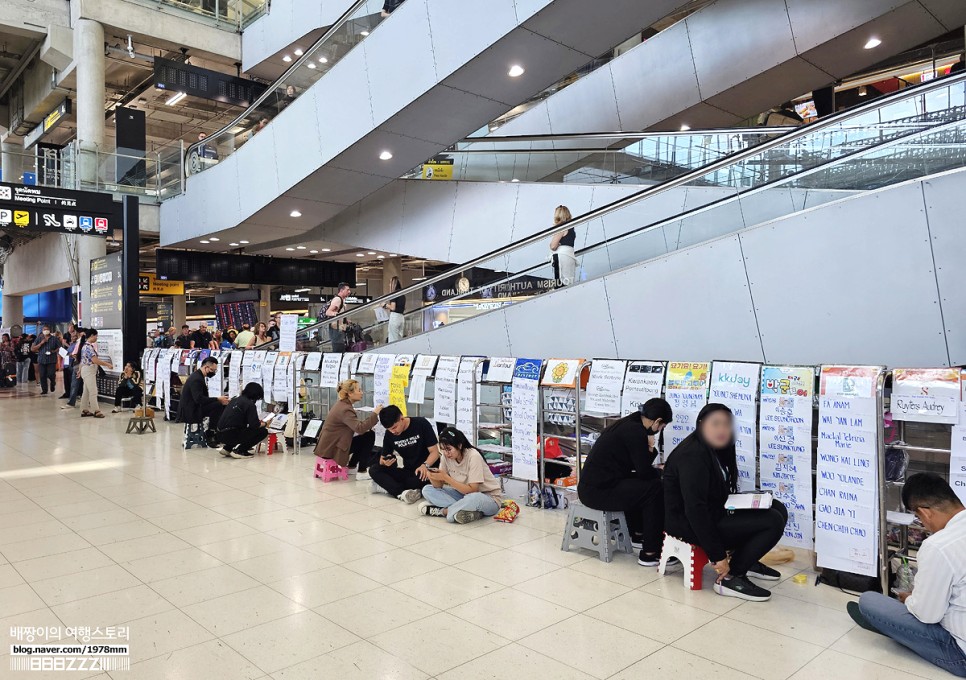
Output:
[369, 405, 439, 503]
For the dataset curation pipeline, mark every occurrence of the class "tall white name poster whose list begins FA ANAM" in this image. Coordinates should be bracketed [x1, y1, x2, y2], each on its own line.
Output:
[815, 366, 882, 576]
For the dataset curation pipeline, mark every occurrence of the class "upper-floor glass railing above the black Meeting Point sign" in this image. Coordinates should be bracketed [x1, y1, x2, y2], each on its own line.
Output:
[3, 142, 184, 203]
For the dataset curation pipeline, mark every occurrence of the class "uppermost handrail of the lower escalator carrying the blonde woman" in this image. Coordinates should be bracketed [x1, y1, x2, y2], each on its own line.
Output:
[264, 72, 966, 349]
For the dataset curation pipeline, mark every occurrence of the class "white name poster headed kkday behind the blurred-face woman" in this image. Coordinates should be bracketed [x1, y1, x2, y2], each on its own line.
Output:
[709, 361, 761, 491]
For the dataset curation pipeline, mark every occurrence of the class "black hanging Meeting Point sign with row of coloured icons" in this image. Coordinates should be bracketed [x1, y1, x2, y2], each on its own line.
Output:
[0, 183, 114, 236]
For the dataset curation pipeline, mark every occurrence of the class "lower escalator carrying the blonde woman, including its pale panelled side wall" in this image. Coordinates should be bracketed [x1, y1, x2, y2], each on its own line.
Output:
[280, 74, 966, 365]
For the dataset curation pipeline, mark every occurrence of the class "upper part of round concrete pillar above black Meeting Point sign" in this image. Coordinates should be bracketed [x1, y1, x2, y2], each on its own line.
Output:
[74, 19, 105, 187]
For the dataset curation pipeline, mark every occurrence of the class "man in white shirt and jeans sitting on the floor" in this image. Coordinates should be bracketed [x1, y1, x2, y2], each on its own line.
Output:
[847, 473, 966, 678]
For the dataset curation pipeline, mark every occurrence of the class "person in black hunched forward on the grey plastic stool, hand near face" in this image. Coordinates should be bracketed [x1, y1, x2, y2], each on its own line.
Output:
[577, 397, 673, 567]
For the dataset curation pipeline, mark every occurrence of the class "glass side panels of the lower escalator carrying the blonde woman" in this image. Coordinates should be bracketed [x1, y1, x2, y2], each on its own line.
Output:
[282, 74, 966, 351]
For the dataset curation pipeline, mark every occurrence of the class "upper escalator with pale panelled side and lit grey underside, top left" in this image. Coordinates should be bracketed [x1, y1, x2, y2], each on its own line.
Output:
[161, 0, 700, 250]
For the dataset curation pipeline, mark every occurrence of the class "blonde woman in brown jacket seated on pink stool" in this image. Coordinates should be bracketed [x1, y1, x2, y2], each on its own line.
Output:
[315, 379, 382, 479]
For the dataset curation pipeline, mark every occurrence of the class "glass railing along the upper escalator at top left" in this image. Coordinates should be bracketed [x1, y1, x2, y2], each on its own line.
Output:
[185, 0, 386, 174]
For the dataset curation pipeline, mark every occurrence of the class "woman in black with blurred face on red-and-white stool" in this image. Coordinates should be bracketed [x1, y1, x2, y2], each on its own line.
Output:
[664, 404, 788, 602]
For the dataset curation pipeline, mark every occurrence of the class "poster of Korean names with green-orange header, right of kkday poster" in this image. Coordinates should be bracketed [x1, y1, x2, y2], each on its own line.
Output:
[758, 366, 815, 550]
